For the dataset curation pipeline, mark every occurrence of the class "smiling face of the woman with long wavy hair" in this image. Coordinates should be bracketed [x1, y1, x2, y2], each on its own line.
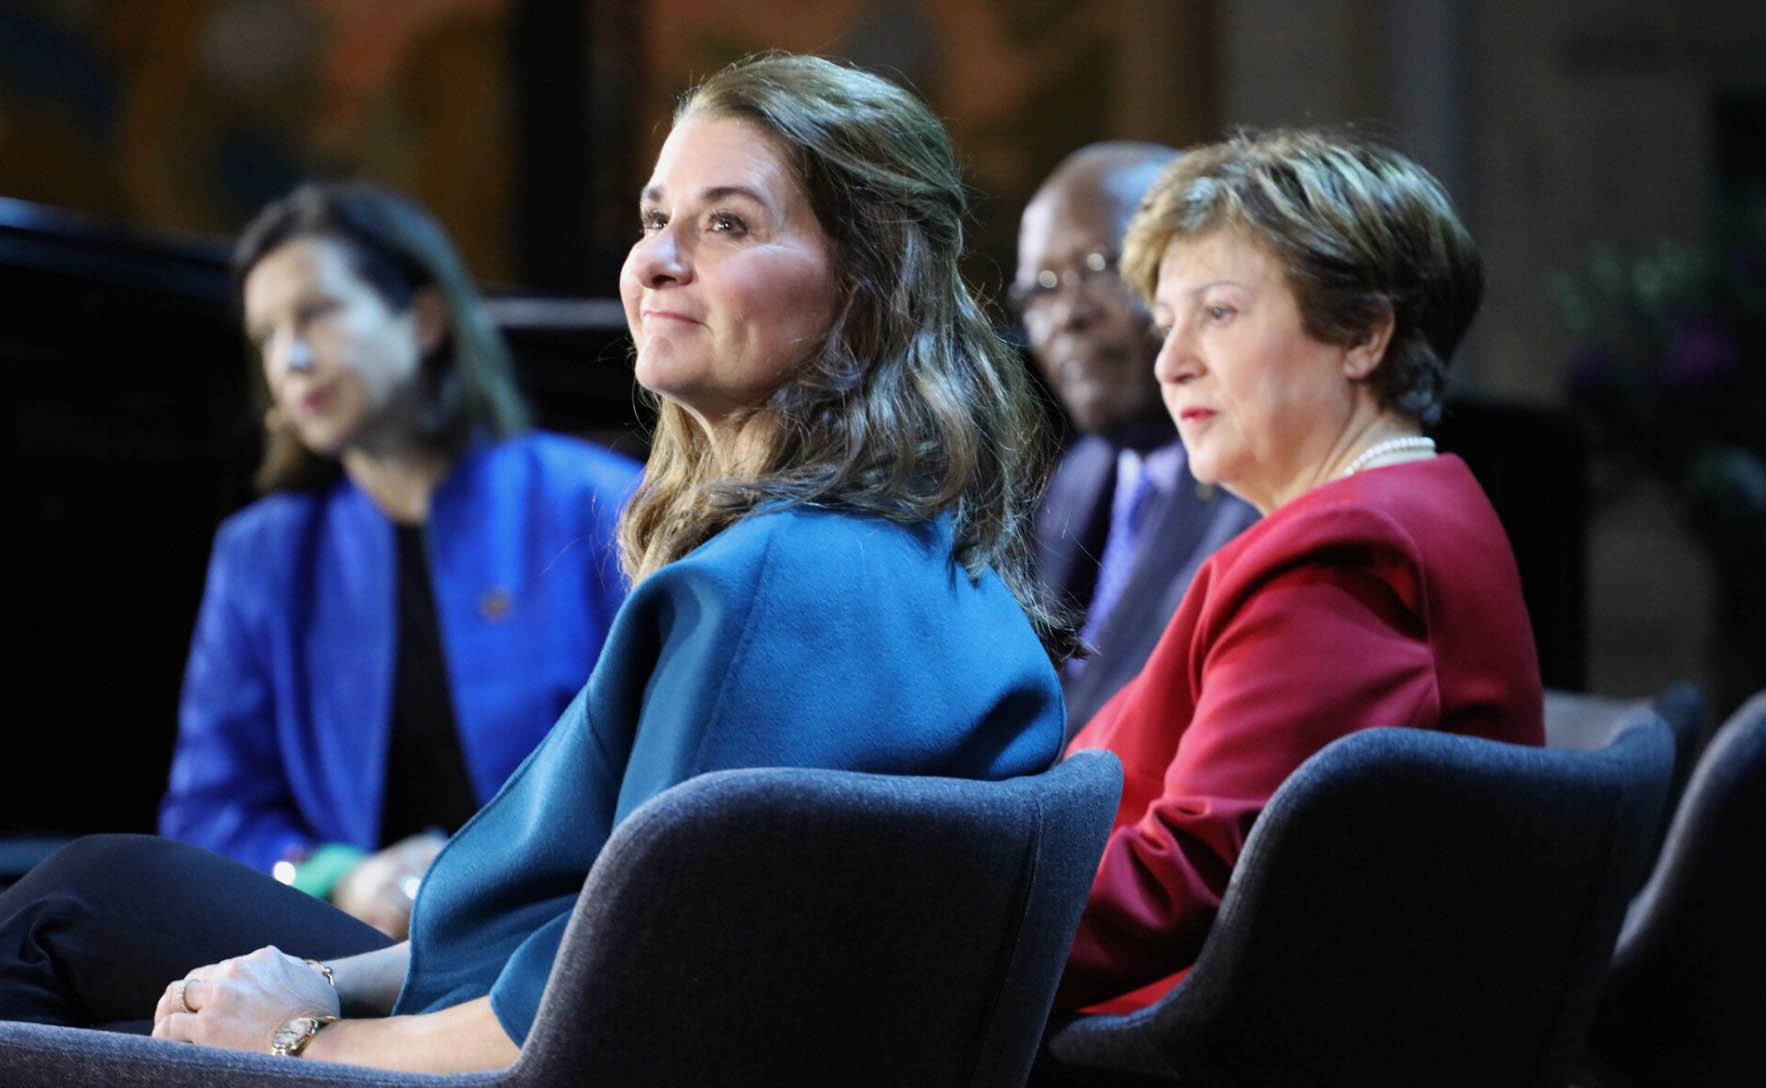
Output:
[620, 115, 834, 431]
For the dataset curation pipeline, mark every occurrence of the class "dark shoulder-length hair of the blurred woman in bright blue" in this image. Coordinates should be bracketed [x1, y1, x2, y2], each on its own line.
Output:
[233, 182, 526, 491]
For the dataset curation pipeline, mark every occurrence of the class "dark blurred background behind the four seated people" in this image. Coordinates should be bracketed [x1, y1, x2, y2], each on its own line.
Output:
[0, 0, 1766, 832]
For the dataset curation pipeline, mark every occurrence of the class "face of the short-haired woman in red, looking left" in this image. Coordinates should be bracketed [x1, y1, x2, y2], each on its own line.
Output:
[1153, 230, 1385, 514]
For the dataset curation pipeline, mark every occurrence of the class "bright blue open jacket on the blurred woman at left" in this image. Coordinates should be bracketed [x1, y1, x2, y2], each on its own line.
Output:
[159, 433, 638, 869]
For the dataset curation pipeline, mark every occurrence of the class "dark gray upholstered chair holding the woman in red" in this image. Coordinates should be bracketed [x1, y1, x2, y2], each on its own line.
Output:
[1038, 719, 1674, 1088]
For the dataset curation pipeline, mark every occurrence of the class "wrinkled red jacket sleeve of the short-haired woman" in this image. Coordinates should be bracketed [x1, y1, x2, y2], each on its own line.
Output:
[1058, 562, 1439, 1009]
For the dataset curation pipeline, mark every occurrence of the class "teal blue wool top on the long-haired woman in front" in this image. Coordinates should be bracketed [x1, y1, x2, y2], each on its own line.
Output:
[394, 507, 1065, 1044]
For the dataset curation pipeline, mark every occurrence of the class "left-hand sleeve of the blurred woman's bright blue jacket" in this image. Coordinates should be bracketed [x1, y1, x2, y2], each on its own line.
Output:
[159, 530, 313, 871]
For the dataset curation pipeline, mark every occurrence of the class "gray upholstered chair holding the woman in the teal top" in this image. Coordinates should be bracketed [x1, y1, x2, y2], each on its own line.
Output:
[0, 752, 1121, 1088]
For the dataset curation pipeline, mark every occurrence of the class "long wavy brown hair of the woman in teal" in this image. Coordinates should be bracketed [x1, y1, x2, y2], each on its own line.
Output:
[620, 55, 1075, 659]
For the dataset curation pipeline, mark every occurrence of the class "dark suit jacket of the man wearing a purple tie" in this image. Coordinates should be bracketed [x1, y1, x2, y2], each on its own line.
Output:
[1037, 434, 1257, 735]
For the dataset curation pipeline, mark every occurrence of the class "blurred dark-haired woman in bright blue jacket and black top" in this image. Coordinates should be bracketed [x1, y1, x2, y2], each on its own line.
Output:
[161, 184, 638, 936]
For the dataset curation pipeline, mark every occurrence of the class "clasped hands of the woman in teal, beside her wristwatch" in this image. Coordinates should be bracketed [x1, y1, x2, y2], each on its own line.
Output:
[154, 948, 339, 1053]
